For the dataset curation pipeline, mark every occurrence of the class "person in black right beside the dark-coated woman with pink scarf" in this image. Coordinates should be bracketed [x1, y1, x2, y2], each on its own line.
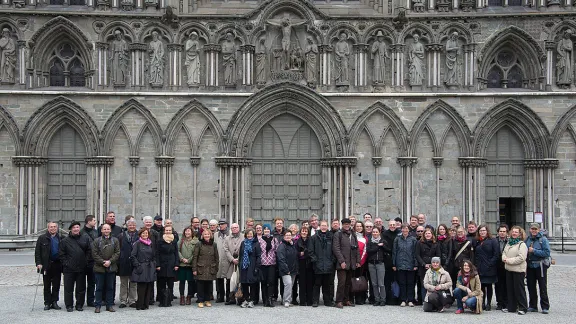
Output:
[156, 226, 180, 307]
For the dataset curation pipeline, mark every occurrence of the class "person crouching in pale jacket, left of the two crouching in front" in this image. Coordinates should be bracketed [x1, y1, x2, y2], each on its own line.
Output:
[422, 256, 452, 313]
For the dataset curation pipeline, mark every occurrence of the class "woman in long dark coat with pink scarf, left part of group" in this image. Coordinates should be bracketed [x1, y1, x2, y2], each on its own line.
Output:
[130, 228, 156, 310]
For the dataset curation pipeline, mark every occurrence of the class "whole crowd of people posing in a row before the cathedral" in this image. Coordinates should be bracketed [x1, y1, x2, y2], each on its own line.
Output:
[35, 212, 551, 315]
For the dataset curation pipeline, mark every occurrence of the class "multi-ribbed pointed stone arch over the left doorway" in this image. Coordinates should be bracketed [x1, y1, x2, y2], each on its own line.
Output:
[22, 97, 100, 156]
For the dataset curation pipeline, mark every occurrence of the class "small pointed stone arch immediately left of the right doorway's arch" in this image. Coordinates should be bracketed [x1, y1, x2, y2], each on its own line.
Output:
[410, 100, 470, 156]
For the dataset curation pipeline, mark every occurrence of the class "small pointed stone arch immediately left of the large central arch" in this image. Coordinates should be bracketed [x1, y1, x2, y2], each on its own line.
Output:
[166, 99, 224, 155]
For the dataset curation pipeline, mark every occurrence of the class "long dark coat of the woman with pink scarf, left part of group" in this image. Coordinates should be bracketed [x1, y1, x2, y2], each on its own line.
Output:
[130, 240, 157, 282]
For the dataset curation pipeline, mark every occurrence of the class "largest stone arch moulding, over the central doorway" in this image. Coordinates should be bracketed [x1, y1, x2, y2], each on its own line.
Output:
[226, 82, 346, 157]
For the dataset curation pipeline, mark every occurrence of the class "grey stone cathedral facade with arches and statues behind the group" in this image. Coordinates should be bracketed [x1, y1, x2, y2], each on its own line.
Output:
[0, 0, 576, 240]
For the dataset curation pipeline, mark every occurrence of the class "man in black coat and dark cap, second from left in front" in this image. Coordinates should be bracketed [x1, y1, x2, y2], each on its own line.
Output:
[59, 222, 92, 312]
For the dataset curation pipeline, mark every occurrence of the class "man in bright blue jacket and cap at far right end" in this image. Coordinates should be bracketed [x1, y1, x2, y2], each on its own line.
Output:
[526, 223, 550, 314]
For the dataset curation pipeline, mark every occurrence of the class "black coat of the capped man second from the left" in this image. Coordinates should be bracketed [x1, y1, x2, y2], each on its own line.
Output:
[58, 235, 92, 272]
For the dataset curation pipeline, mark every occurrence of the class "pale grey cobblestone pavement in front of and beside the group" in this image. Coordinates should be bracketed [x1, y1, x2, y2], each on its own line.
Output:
[0, 266, 576, 324]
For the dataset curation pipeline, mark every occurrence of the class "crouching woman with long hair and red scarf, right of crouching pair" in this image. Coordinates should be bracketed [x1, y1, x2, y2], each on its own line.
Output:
[454, 260, 484, 314]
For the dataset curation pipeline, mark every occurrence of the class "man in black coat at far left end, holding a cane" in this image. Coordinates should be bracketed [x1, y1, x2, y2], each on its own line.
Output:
[34, 222, 62, 310]
